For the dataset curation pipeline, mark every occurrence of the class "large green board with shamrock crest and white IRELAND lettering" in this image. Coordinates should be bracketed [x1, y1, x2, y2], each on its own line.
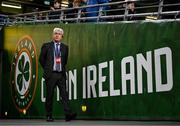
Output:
[1, 21, 180, 120]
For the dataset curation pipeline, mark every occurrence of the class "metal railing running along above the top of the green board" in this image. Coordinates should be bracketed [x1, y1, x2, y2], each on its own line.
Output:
[0, 0, 180, 25]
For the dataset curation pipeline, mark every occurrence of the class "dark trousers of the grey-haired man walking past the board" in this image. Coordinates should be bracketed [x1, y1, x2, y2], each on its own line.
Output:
[45, 72, 71, 116]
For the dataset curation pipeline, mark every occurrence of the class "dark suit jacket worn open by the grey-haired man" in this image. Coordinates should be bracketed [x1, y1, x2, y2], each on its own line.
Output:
[39, 41, 68, 79]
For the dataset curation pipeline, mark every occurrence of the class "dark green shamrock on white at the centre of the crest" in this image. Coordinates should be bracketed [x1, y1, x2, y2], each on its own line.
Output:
[17, 55, 30, 91]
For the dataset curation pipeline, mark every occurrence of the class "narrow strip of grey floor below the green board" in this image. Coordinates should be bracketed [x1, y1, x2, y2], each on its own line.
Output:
[0, 119, 180, 126]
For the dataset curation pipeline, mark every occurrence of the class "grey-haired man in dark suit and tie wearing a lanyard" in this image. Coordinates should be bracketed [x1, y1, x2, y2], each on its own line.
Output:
[39, 28, 76, 121]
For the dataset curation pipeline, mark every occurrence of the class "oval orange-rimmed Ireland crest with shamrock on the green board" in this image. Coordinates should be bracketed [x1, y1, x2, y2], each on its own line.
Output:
[11, 36, 38, 112]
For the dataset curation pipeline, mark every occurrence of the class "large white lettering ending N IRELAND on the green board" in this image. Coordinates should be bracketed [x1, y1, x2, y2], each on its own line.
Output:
[41, 47, 173, 102]
